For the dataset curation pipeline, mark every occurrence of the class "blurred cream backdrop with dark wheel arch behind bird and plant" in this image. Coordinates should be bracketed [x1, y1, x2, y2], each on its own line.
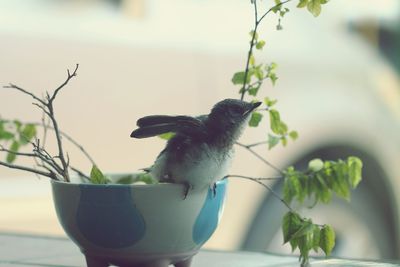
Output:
[0, 0, 400, 259]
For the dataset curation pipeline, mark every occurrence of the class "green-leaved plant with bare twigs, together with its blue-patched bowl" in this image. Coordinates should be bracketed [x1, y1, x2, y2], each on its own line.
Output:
[0, 0, 362, 266]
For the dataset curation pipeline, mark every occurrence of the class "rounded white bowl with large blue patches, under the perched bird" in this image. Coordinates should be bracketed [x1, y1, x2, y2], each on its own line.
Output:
[52, 180, 227, 267]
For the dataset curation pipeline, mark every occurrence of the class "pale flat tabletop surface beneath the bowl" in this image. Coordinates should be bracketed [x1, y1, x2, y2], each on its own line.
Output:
[0, 233, 400, 267]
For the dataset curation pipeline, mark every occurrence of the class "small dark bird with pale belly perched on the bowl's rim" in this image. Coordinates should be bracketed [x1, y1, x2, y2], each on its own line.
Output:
[130, 99, 261, 199]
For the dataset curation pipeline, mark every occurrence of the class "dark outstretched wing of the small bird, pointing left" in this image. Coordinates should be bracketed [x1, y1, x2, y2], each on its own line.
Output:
[131, 115, 206, 138]
